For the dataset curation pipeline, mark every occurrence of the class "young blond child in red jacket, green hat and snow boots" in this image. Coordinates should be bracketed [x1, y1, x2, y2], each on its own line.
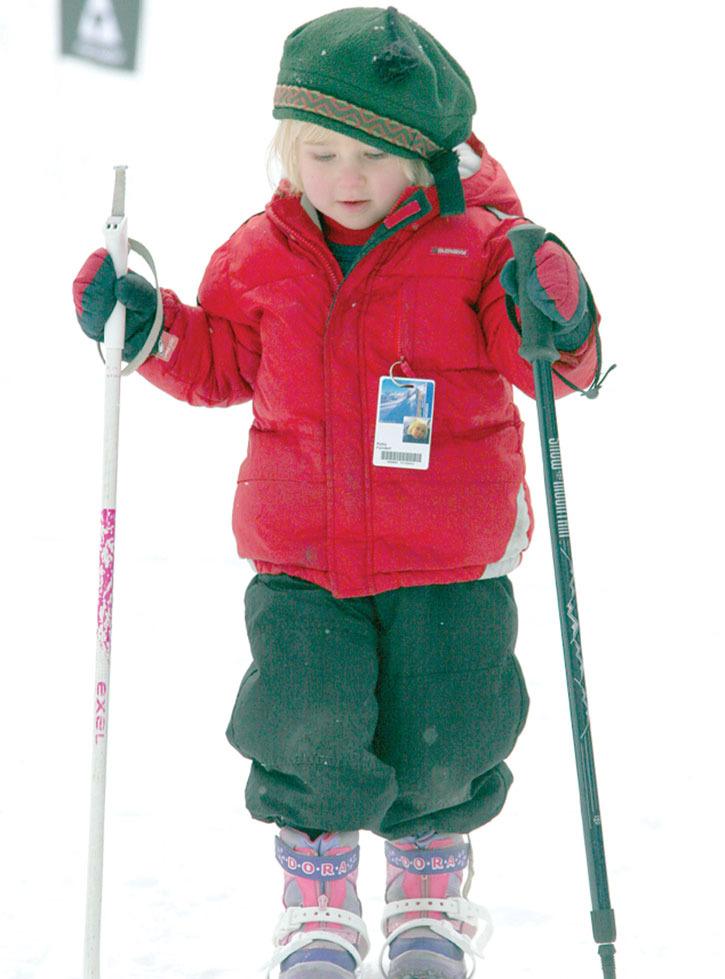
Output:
[74, 7, 598, 979]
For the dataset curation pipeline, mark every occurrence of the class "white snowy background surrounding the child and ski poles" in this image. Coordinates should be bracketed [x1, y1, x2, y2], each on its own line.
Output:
[0, 0, 725, 979]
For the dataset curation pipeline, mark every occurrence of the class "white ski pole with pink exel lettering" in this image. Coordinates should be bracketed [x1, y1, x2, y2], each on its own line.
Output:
[83, 166, 128, 979]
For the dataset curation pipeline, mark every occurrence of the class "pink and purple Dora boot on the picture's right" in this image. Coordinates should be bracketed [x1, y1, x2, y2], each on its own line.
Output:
[380, 833, 493, 979]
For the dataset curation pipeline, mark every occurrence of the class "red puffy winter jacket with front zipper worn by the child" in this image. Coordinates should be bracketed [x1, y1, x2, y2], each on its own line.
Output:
[140, 136, 596, 598]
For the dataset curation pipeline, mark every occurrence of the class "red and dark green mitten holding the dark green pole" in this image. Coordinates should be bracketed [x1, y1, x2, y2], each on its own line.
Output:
[500, 234, 593, 351]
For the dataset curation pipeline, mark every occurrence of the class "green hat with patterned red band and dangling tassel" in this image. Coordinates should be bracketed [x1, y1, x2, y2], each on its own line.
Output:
[273, 7, 476, 214]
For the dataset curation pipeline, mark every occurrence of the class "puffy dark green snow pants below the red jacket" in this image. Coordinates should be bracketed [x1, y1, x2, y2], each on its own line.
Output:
[227, 574, 528, 839]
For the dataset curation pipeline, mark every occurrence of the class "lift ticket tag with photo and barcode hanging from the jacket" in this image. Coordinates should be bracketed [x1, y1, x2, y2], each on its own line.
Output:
[373, 375, 435, 469]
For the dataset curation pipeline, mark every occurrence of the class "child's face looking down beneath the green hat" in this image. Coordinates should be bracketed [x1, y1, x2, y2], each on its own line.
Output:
[298, 130, 409, 230]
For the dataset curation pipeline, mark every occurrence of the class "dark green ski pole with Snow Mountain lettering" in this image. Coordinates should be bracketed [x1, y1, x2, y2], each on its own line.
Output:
[508, 224, 616, 979]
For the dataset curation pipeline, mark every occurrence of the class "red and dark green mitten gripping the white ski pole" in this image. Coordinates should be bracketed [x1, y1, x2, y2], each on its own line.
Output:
[73, 248, 156, 360]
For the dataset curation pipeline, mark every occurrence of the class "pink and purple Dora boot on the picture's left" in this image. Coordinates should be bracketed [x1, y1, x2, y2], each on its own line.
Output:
[267, 828, 370, 979]
